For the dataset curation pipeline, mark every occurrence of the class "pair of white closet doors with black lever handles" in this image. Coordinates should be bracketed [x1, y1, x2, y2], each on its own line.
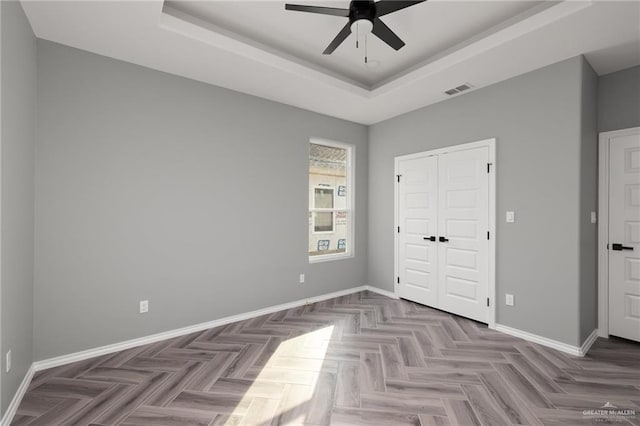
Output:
[396, 146, 491, 323]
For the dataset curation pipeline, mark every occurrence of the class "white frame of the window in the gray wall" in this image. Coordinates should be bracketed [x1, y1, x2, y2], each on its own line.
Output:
[307, 138, 356, 263]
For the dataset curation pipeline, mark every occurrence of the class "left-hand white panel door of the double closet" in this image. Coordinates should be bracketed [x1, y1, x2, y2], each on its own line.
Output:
[398, 156, 438, 307]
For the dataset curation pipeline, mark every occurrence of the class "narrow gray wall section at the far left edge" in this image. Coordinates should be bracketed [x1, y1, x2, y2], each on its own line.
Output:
[0, 1, 36, 413]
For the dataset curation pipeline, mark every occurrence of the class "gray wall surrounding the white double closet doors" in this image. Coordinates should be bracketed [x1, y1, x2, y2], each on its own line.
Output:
[368, 57, 595, 345]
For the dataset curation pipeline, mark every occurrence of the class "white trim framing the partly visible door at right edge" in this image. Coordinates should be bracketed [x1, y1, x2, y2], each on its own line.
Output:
[598, 127, 640, 338]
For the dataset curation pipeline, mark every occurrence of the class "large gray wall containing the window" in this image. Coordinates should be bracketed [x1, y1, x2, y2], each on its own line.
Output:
[35, 41, 368, 360]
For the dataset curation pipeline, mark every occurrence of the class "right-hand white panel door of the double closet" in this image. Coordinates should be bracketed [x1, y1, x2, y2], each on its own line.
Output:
[438, 147, 489, 323]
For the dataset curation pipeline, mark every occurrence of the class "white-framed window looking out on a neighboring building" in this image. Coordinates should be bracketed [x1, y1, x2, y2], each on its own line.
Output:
[309, 140, 353, 262]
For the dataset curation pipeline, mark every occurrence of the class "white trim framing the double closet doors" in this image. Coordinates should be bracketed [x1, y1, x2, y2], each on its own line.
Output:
[393, 138, 498, 329]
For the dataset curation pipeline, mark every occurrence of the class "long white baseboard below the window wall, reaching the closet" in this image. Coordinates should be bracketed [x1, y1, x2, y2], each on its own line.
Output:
[33, 285, 398, 371]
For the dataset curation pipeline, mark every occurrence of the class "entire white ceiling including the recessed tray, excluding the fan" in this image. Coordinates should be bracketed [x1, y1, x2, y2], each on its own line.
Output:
[22, 0, 640, 124]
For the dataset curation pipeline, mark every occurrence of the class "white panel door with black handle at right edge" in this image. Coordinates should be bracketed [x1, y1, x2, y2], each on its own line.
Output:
[609, 134, 640, 341]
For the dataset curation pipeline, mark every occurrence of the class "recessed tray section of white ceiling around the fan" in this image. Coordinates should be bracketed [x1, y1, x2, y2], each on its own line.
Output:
[164, 0, 541, 88]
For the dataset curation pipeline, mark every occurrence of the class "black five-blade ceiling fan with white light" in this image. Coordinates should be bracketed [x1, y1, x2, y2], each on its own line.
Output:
[285, 0, 426, 62]
